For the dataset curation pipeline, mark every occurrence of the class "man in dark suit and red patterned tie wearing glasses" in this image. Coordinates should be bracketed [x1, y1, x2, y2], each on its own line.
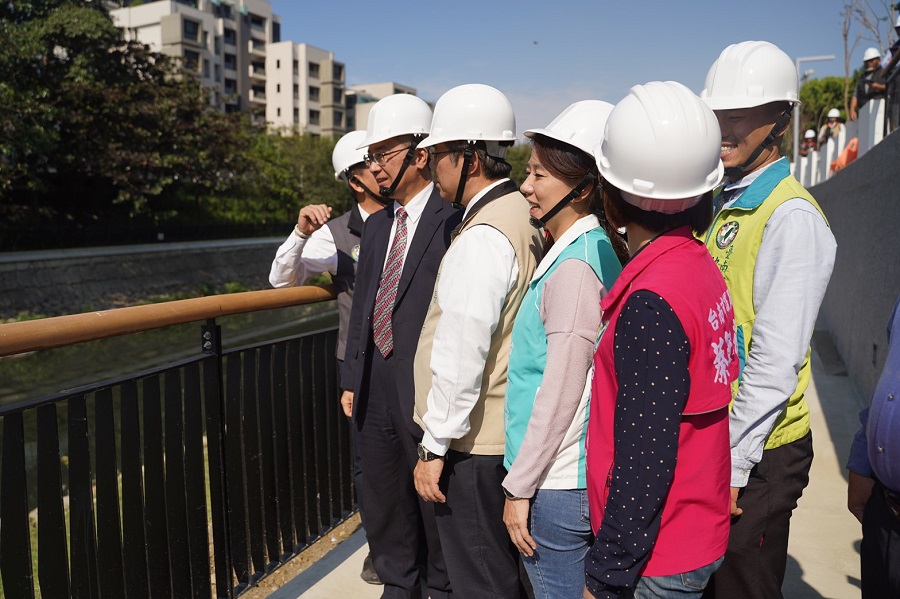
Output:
[341, 94, 462, 599]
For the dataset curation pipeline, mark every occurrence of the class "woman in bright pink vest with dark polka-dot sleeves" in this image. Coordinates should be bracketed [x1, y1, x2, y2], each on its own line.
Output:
[585, 82, 738, 599]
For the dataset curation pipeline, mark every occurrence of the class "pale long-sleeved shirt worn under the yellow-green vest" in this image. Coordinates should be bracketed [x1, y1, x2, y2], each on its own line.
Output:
[725, 158, 837, 487]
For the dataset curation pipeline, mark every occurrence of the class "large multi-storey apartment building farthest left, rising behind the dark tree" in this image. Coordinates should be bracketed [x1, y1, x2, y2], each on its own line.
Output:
[110, 0, 281, 118]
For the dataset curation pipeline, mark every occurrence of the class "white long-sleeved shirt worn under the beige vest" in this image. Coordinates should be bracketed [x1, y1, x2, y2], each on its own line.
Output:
[422, 179, 519, 455]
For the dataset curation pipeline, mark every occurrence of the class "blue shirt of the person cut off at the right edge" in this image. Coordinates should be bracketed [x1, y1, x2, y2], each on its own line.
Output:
[847, 298, 900, 493]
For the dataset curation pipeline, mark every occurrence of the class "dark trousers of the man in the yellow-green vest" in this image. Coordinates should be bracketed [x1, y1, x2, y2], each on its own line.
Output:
[703, 433, 813, 599]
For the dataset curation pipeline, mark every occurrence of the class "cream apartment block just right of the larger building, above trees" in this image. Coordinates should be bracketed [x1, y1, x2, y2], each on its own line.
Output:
[266, 42, 351, 136]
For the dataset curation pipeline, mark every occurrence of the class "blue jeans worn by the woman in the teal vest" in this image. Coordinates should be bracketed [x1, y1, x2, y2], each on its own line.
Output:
[522, 489, 594, 599]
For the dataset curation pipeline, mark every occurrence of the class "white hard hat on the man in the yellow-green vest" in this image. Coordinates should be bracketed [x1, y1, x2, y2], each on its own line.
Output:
[700, 41, 800, 110]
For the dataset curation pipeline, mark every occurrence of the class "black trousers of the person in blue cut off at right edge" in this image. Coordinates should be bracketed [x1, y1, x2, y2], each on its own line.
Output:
[859, 483, 900, 599]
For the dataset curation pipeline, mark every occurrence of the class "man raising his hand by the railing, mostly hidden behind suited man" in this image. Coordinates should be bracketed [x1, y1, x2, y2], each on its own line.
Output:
[269, 131, 387, 584]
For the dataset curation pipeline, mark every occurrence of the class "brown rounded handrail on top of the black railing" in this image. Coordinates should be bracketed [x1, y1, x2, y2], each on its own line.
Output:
[0, 285, 336, 357]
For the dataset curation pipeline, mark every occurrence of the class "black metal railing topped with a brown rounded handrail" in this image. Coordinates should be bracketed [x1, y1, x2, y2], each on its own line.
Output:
[0, 287, 355, 599]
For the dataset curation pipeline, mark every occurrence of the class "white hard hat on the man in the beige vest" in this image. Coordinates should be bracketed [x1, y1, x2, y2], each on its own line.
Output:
[419, 83, 516, 158]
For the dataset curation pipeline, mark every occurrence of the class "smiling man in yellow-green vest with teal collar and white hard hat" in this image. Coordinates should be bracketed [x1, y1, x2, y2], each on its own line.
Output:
[700, 41, 837, 599]
